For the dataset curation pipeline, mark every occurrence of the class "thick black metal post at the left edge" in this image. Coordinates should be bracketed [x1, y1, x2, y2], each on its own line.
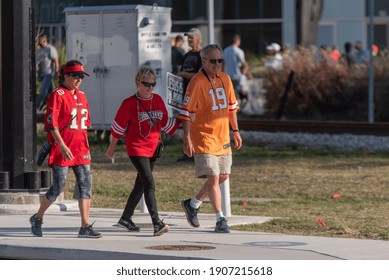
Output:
[0, 0, 37, 189]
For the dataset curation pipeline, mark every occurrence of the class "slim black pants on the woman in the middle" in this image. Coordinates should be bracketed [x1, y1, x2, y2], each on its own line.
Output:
[122, 157, 159, 225]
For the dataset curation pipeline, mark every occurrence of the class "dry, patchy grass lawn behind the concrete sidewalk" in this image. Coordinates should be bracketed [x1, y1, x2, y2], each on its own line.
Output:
[47, 133, 389, 240]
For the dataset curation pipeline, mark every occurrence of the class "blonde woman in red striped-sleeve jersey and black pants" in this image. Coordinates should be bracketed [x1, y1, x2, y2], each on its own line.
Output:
[106, 66, 180, 236]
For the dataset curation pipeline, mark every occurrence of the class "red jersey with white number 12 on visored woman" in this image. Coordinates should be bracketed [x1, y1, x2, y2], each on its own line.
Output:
[45, 86, 91, 166]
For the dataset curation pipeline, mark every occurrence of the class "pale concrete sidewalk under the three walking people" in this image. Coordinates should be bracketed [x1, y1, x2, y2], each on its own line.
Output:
[0, 206, 389, 260]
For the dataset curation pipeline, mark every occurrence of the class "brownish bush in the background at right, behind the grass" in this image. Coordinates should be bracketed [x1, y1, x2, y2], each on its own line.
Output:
[264, 48, 389, 121]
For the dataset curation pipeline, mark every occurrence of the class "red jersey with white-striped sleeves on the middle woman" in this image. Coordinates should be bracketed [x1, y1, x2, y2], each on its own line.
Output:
[111, 93, 180, 157]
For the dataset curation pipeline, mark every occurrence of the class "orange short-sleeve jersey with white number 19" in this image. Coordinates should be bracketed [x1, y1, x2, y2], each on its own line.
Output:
[180, 68, 238, 155]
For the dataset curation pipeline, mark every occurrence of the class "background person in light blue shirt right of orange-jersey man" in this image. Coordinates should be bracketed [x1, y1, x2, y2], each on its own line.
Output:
[223, 35, 247, 101]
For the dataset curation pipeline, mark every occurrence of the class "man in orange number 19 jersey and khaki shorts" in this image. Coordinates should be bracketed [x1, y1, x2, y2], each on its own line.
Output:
[180, 44, 242, 233]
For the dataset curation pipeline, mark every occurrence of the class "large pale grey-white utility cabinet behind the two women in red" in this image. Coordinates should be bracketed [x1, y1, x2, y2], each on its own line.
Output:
[64, 5, 172, 130]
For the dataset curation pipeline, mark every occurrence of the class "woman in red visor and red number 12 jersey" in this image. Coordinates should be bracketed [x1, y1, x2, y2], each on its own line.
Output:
[30, 60, 102, 238]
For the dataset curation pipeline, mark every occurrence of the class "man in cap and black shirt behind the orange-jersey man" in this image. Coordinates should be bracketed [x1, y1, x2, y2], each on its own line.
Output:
[177, 28, 202, 162]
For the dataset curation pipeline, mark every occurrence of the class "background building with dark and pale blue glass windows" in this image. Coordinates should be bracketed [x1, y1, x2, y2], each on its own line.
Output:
[35, 0, 389, 54]
